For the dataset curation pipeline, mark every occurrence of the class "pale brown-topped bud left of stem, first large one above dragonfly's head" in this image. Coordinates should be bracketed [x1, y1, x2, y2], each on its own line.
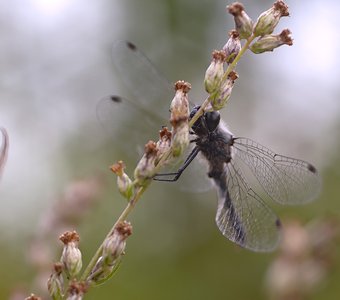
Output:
[204, 50, 226, 94]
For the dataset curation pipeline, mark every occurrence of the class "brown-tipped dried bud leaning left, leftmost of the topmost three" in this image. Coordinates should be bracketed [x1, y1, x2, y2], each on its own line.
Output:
[227, 2, 253, 40]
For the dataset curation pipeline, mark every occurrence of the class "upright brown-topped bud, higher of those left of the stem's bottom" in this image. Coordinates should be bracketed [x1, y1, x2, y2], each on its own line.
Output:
[59, 231, 82, 278]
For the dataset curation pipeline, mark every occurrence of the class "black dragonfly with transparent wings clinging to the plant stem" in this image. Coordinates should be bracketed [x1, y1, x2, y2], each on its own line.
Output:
[99, 41, 321, 252]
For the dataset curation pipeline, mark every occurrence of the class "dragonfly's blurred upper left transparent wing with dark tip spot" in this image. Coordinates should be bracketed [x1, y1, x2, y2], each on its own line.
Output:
[112, 40, 174, 119]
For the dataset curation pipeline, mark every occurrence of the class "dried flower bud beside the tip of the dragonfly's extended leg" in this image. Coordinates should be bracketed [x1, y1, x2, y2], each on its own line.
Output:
[134, 141, 158, 185]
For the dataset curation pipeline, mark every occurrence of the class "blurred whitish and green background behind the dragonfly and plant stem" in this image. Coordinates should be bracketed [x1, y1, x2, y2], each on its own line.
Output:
[0, 0, 340, 299]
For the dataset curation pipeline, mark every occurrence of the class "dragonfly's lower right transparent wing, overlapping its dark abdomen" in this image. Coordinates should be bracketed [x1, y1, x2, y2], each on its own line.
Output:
[214, 161, 280, 252]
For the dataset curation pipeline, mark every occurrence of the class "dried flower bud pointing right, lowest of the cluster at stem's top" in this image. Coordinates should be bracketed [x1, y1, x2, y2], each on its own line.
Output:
[249, 29, 293, 54]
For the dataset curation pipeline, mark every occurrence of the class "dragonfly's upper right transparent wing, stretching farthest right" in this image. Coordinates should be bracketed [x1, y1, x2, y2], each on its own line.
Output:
[234, 138, 321, 204]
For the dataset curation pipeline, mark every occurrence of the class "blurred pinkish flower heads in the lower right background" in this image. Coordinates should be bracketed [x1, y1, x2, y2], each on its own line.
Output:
[266, 218, 340, 300]
